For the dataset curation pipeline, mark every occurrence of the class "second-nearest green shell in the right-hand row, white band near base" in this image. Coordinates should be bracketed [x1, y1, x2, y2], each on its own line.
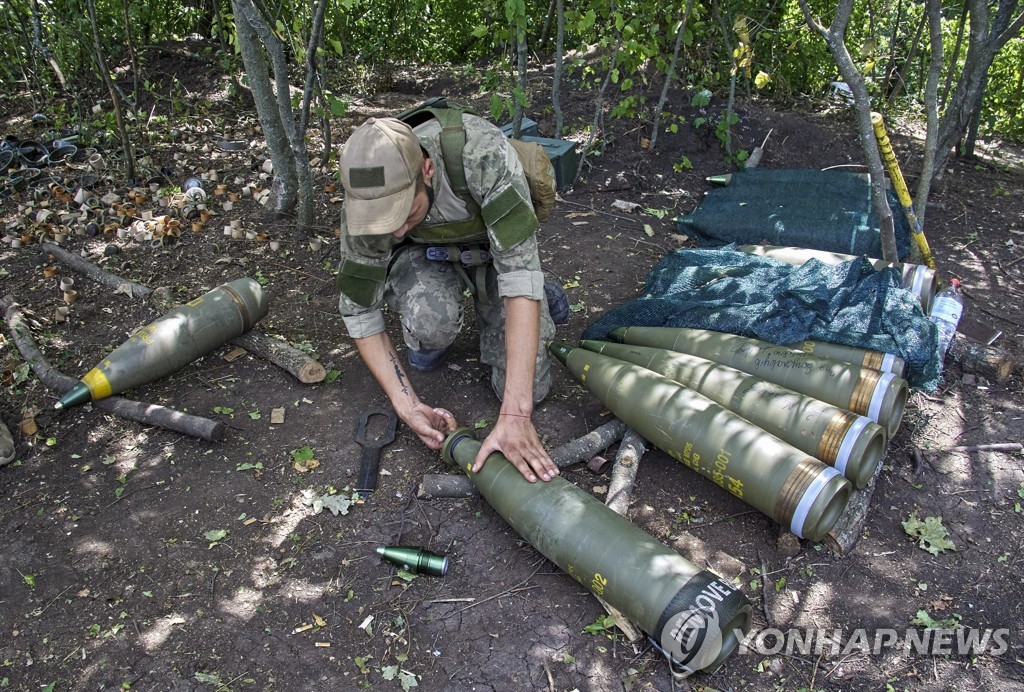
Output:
[583, 341, 886, 488]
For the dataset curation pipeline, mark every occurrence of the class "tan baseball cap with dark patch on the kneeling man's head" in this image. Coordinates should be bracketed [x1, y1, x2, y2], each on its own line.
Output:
[340, 118, 423, 235]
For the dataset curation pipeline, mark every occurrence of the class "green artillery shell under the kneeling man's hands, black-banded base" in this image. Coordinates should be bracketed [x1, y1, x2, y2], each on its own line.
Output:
[441, 428, 752, 671]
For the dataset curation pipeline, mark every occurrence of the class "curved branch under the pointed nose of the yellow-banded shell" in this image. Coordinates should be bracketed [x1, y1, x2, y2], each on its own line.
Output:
[0, 296, 227, 442]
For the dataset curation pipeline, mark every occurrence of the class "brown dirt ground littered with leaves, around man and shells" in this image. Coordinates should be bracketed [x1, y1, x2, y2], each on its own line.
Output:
[0, 46, 1024, 690]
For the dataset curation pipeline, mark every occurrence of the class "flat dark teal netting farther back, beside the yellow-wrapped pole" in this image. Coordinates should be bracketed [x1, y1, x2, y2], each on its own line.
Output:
[677, 168, 910, 260]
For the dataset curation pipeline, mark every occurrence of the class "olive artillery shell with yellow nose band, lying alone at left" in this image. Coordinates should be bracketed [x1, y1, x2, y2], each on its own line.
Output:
[56, 277, 267, 408]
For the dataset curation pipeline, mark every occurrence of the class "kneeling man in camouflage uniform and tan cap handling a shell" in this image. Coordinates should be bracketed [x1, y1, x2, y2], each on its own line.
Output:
[338, 112, 558, 482]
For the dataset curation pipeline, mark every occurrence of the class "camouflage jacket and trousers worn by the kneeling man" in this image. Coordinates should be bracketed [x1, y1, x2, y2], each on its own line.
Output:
[338, 114, 555, 402]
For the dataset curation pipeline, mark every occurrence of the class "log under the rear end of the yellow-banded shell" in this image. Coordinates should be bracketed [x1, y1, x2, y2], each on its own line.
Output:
[39, 243, 327, 385]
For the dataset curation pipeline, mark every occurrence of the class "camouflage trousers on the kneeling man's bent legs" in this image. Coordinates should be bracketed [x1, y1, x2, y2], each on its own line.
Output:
[384, 246, 555, 403]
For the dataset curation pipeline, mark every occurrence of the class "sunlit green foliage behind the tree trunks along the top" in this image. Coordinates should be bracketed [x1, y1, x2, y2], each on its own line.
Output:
[0, 0, 1024, 140]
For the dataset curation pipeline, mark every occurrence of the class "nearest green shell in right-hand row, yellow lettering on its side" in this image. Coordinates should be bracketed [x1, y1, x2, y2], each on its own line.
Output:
[548, 343, 850, 542]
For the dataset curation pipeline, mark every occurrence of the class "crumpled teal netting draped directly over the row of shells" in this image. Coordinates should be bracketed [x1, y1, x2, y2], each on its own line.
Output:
[583, 248, 939, 391]
